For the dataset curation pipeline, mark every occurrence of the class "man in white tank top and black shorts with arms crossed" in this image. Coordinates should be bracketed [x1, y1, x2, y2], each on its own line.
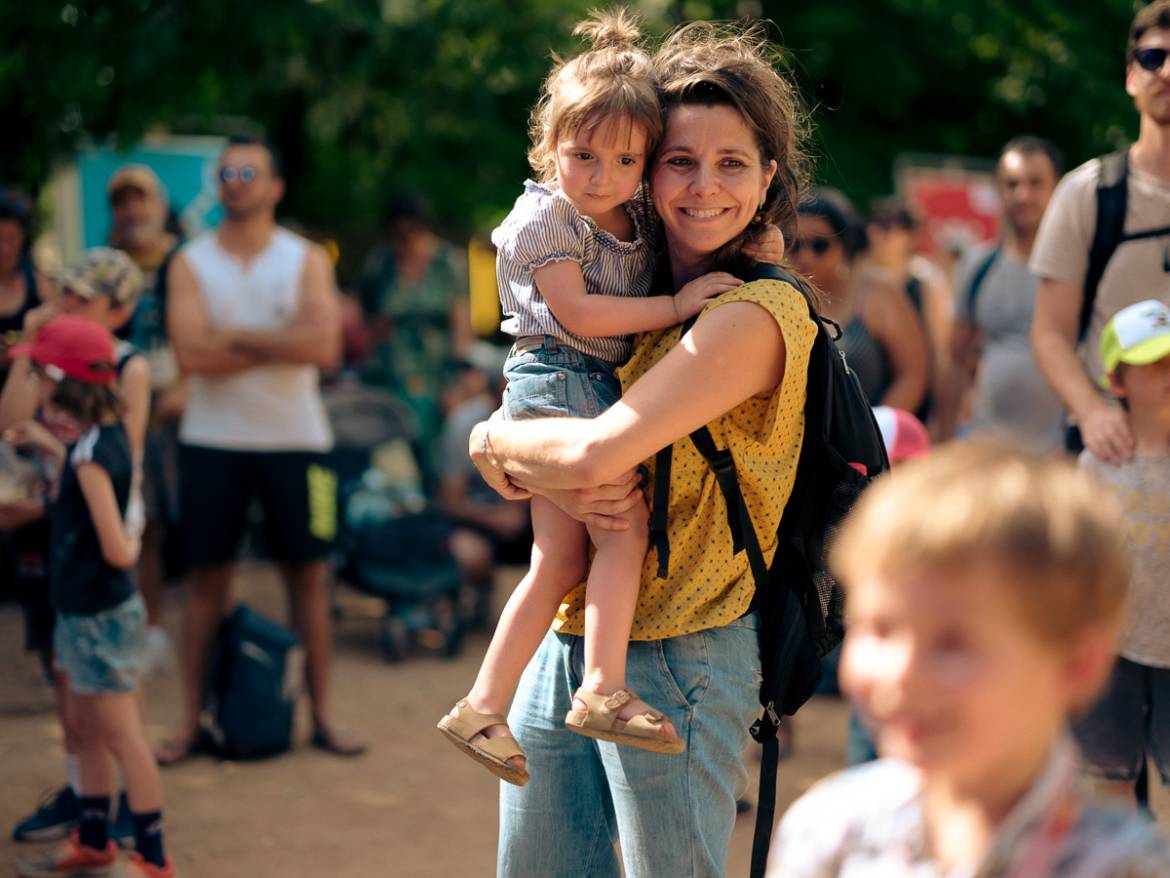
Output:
[158, 138, 363, 764]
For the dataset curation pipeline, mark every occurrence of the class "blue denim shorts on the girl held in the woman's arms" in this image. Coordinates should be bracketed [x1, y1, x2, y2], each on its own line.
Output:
[502, 336, 621, 420]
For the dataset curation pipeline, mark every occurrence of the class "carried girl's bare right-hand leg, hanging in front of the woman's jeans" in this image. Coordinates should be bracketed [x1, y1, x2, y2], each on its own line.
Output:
[573, 499, 675, 736]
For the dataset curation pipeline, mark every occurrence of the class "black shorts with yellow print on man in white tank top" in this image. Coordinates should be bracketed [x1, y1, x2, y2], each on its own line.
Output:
[179, 445, 337, 567]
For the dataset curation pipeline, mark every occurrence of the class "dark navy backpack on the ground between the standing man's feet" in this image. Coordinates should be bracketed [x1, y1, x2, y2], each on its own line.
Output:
[204, 604, 304, 759]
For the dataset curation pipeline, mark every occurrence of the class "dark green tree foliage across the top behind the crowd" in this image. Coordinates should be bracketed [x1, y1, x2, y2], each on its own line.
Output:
[0, 0, 1136, 271]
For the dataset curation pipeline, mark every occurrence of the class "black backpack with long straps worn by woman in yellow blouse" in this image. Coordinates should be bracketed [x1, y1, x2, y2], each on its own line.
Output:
[651, 265, 889, 878]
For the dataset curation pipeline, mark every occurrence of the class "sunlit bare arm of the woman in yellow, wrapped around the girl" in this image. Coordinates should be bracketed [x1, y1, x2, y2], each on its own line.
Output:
[469, 302, 786, 489]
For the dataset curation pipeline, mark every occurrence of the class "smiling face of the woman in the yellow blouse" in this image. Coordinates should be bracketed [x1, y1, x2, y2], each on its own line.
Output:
[651, 104, 776, 280]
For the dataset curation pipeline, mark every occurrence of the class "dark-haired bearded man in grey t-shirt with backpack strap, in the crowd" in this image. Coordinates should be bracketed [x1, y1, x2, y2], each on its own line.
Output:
[938, 137, 1065, 451]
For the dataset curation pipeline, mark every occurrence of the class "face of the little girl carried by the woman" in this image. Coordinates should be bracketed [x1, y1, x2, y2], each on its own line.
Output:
[557, 118, 646, 218]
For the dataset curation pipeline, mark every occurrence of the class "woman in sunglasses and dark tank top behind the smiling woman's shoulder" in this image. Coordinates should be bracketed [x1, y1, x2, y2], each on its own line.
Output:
[789, 188, 930, 412]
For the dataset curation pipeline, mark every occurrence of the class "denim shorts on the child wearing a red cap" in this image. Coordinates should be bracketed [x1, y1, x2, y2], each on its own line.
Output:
[53, 591, 146, 695]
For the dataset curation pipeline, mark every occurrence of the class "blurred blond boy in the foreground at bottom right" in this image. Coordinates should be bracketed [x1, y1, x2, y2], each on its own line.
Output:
[769, 441, 1170, 878]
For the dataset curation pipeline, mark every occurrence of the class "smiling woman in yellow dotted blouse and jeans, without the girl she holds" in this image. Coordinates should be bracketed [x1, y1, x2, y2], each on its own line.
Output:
[460, 15, 817, 876]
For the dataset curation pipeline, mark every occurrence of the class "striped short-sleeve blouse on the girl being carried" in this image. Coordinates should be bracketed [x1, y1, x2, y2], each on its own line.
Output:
[491, 180, 656, 365]
